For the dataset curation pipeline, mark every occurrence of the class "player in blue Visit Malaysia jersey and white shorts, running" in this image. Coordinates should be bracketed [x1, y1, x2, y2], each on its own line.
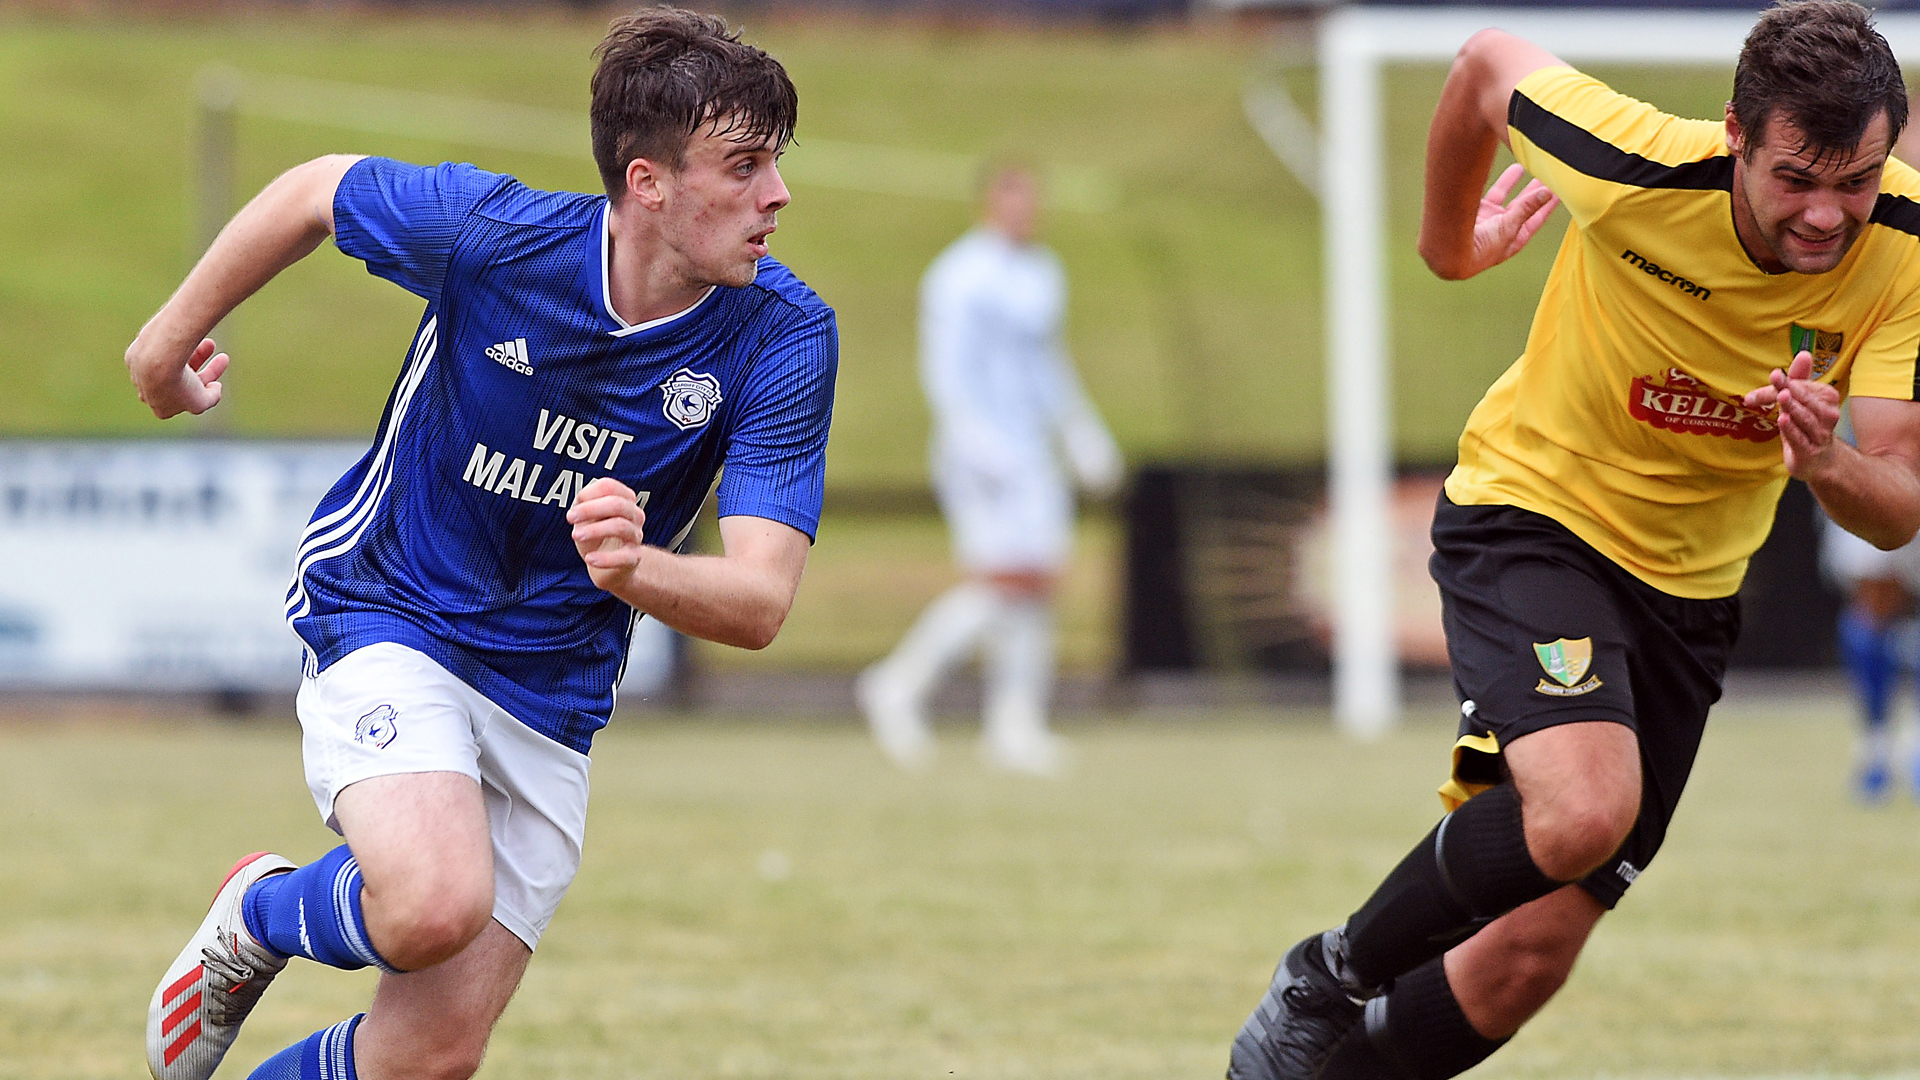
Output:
[127, 8, 837, 1080]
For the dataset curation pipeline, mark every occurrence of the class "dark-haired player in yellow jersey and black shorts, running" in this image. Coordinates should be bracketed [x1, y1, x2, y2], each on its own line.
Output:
[1227, 0, 1920, 1080]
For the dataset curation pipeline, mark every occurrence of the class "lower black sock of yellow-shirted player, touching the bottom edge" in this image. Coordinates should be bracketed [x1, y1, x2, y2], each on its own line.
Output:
[1319, 957, 1507, 1080]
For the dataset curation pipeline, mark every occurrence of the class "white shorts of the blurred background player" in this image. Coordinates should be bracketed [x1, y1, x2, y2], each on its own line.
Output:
[933, 453, 1073, 573]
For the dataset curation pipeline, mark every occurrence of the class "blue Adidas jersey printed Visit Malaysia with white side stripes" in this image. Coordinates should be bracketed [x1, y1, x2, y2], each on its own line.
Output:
[286, 158, 839, 753]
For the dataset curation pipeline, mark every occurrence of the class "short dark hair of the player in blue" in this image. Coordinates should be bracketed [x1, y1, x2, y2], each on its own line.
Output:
[589, 4, 799, 200]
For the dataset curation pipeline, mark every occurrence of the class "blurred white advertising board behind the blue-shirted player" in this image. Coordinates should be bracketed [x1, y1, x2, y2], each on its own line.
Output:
[0, 440, 674, 694]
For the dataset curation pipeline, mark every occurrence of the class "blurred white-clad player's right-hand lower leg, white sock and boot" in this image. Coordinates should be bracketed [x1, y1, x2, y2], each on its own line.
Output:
[981, 598, 1066, 776]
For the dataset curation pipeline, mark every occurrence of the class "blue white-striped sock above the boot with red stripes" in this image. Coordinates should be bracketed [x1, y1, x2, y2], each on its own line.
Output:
[240, 844, 396, 970]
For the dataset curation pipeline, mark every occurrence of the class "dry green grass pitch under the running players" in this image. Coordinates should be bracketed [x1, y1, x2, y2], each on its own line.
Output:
[0, 703, 1920, 1080]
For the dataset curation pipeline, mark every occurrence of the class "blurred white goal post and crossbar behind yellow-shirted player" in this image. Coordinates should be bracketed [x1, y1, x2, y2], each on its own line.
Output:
[1317, 8, 1920, 738]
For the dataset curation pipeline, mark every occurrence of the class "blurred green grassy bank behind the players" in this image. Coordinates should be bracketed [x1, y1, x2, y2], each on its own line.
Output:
[0, 10, 1728, 671]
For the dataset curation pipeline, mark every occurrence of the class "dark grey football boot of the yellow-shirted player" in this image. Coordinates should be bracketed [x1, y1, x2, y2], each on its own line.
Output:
[1227, 926, 1379, 1080]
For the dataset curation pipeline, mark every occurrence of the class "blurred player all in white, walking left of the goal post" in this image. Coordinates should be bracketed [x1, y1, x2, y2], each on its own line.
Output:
[858, 165, 1123, 776]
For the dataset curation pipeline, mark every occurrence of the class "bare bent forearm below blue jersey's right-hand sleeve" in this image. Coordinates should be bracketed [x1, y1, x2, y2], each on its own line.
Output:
[609, 548, 797, 650]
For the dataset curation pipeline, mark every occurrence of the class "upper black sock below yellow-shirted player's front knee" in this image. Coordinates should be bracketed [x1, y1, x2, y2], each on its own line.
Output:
[1346, 782, 1561, 990]
